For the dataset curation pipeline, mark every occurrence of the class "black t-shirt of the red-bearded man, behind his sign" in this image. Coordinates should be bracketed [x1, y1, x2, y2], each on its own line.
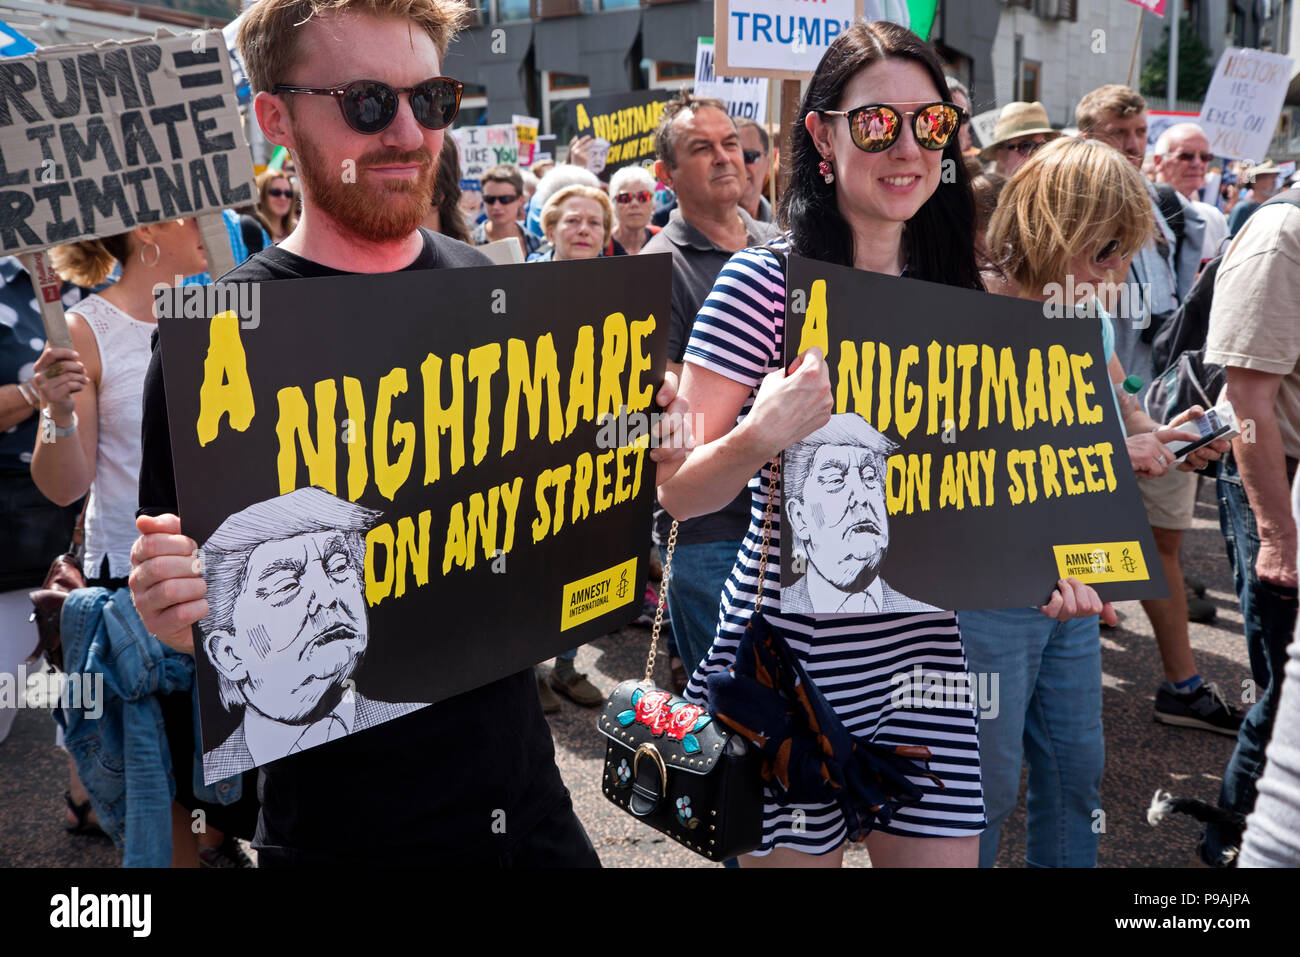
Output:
[139, 230, 571, 865]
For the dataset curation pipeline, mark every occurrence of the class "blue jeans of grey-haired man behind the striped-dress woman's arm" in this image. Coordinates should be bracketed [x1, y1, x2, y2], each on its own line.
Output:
[659, 538, 741, 676]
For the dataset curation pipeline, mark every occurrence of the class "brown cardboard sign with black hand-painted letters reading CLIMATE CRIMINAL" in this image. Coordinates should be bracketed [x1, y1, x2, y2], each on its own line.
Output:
[0, 30, 255, 256]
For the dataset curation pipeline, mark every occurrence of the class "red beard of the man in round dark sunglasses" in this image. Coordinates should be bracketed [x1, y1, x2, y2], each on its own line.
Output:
[294, 128, 438, 243]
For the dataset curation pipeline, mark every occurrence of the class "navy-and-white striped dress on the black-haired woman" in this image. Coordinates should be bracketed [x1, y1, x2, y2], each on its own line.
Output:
[685, 241, 985, 854]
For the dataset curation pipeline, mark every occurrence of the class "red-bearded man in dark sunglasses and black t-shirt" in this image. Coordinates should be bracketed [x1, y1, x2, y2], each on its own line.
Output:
[131, 0, 599, 866]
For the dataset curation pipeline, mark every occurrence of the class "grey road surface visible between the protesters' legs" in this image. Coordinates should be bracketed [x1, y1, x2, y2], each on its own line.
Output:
[0, 481, 1249, 867]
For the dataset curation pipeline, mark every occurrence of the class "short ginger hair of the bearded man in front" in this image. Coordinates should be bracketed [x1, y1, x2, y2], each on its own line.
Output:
[238, 0, 469, 92]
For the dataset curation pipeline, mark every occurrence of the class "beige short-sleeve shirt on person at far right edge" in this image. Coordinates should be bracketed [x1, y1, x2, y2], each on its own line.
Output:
[1205, 203, 1300, 458]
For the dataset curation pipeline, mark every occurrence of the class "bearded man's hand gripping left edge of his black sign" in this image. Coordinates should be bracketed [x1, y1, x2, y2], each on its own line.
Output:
[130, 515, 208, 654]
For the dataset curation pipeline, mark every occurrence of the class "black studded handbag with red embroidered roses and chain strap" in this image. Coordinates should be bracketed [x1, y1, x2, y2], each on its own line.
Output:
[597, 463, 779, 862]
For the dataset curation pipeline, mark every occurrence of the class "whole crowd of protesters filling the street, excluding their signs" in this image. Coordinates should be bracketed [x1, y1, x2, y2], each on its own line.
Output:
[0, 0, 1300, 867]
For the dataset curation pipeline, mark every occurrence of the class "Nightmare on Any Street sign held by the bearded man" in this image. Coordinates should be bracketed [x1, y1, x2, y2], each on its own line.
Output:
[160, 256, 671, 778]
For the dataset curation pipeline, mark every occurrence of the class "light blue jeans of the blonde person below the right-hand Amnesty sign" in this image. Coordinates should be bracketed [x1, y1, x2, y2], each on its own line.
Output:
[958, 609, 1106, 867]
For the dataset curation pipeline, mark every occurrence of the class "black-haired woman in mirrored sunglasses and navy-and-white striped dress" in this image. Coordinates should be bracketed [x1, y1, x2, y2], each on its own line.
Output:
[658, 22, 1101, 866]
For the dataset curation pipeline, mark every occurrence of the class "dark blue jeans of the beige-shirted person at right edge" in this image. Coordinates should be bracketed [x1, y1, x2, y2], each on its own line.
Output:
[1201, 456, 1296, 865]
